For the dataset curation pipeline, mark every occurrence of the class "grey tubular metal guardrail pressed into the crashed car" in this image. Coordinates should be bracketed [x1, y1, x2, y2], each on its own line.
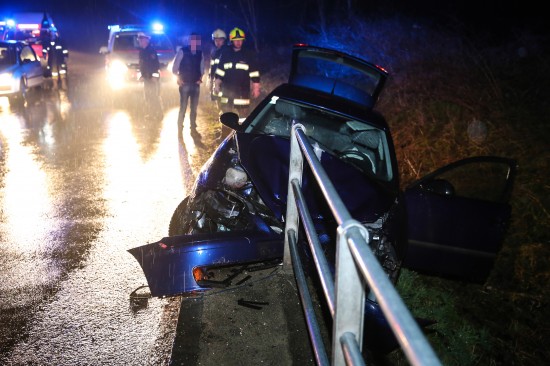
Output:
[283, 124, 441, 366]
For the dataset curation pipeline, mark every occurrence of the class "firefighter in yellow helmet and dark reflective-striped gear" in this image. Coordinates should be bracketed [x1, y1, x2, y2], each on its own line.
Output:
[214, 28, 260, 138]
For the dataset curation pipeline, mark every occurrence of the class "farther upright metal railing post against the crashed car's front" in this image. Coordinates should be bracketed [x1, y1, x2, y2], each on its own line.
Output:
[283, 124, 304, 273]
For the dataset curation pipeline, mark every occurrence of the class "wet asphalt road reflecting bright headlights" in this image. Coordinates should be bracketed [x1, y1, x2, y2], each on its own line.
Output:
[0, 53, 218, 365]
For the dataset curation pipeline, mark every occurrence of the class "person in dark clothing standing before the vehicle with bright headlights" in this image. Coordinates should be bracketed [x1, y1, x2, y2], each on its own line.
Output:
[137, 32, 162, 117]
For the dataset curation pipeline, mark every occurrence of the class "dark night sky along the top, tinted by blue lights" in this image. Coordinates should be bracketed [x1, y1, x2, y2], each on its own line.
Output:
[0, 0, 544, 50]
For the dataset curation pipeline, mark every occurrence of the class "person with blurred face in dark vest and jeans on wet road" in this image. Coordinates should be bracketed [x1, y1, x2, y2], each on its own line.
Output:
[172, 33, 204, 139]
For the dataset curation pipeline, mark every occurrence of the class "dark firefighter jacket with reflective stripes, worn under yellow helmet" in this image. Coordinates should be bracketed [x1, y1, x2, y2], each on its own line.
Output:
[216, 47, 260, 106]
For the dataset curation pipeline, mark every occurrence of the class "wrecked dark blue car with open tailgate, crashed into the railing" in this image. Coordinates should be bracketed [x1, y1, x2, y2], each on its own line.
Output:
[129, 45, 515, 351]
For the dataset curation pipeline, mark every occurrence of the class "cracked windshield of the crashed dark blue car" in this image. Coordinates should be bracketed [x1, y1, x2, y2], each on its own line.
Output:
[245, 96, 393, 181]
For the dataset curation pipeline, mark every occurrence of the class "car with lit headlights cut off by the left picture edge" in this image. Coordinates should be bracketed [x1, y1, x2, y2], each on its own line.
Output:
[0, 41, 44, 106]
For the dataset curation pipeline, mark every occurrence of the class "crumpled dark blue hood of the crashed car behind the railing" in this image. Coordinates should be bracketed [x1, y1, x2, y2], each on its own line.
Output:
[233, 133, 398, 222]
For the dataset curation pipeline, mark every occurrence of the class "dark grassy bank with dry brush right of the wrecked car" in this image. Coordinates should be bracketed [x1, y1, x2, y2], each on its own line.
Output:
[270, 18, 550, 365]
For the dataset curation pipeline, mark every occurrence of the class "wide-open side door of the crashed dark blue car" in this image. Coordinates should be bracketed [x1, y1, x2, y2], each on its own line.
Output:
[403, 157, 516, 282]
